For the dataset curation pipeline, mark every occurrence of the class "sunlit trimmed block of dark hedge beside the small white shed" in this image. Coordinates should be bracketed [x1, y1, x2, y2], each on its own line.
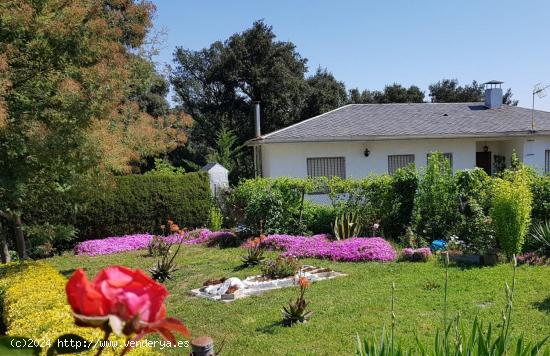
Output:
[76, 172, 211, 239]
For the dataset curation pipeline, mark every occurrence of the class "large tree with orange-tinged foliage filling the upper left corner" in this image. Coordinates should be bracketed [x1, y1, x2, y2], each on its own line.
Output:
[0, 0, 185, 258]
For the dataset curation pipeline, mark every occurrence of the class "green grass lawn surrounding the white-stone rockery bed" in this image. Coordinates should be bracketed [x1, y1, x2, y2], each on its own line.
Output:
[48, 246, 550, 355]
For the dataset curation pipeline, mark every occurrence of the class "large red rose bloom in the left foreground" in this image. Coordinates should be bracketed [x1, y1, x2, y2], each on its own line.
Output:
[66, 266, 189, 342]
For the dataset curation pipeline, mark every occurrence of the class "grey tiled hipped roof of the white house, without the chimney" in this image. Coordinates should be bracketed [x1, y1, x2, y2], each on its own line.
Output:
[251, 103, 550, 144]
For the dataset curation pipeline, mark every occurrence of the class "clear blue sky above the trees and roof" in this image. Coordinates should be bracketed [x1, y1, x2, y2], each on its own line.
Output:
[153, 0, 550, 111]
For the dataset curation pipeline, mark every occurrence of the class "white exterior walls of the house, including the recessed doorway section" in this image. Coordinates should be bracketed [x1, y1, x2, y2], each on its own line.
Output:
[262, 136, 550, 178]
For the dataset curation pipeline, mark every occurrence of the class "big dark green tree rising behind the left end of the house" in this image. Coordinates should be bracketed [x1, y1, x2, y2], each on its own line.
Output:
[171, 21, 307, 175]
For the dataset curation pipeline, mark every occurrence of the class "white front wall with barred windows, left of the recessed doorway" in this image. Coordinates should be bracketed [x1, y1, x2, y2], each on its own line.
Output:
[262, 139, 476, 178]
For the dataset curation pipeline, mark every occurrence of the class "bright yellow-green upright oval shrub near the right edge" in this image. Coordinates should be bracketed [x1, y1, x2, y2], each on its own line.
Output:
[490, 169, 533, 257]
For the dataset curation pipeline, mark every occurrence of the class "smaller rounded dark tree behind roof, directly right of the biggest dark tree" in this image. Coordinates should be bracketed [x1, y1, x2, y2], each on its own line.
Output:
[302, 68, 347, 119]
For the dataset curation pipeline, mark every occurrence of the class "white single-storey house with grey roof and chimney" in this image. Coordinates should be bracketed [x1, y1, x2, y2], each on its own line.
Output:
[248, 81, 550, 178]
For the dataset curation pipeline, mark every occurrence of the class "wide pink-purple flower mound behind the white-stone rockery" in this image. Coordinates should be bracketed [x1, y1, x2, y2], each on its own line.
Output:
[262, 235, 397, 262]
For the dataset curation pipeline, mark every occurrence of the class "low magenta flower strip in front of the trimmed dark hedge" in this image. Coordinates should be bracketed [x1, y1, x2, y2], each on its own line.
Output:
[74, 229, 235, 256]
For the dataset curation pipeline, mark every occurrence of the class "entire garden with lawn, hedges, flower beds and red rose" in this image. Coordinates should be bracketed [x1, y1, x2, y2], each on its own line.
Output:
[0, 154, 550, 355]
